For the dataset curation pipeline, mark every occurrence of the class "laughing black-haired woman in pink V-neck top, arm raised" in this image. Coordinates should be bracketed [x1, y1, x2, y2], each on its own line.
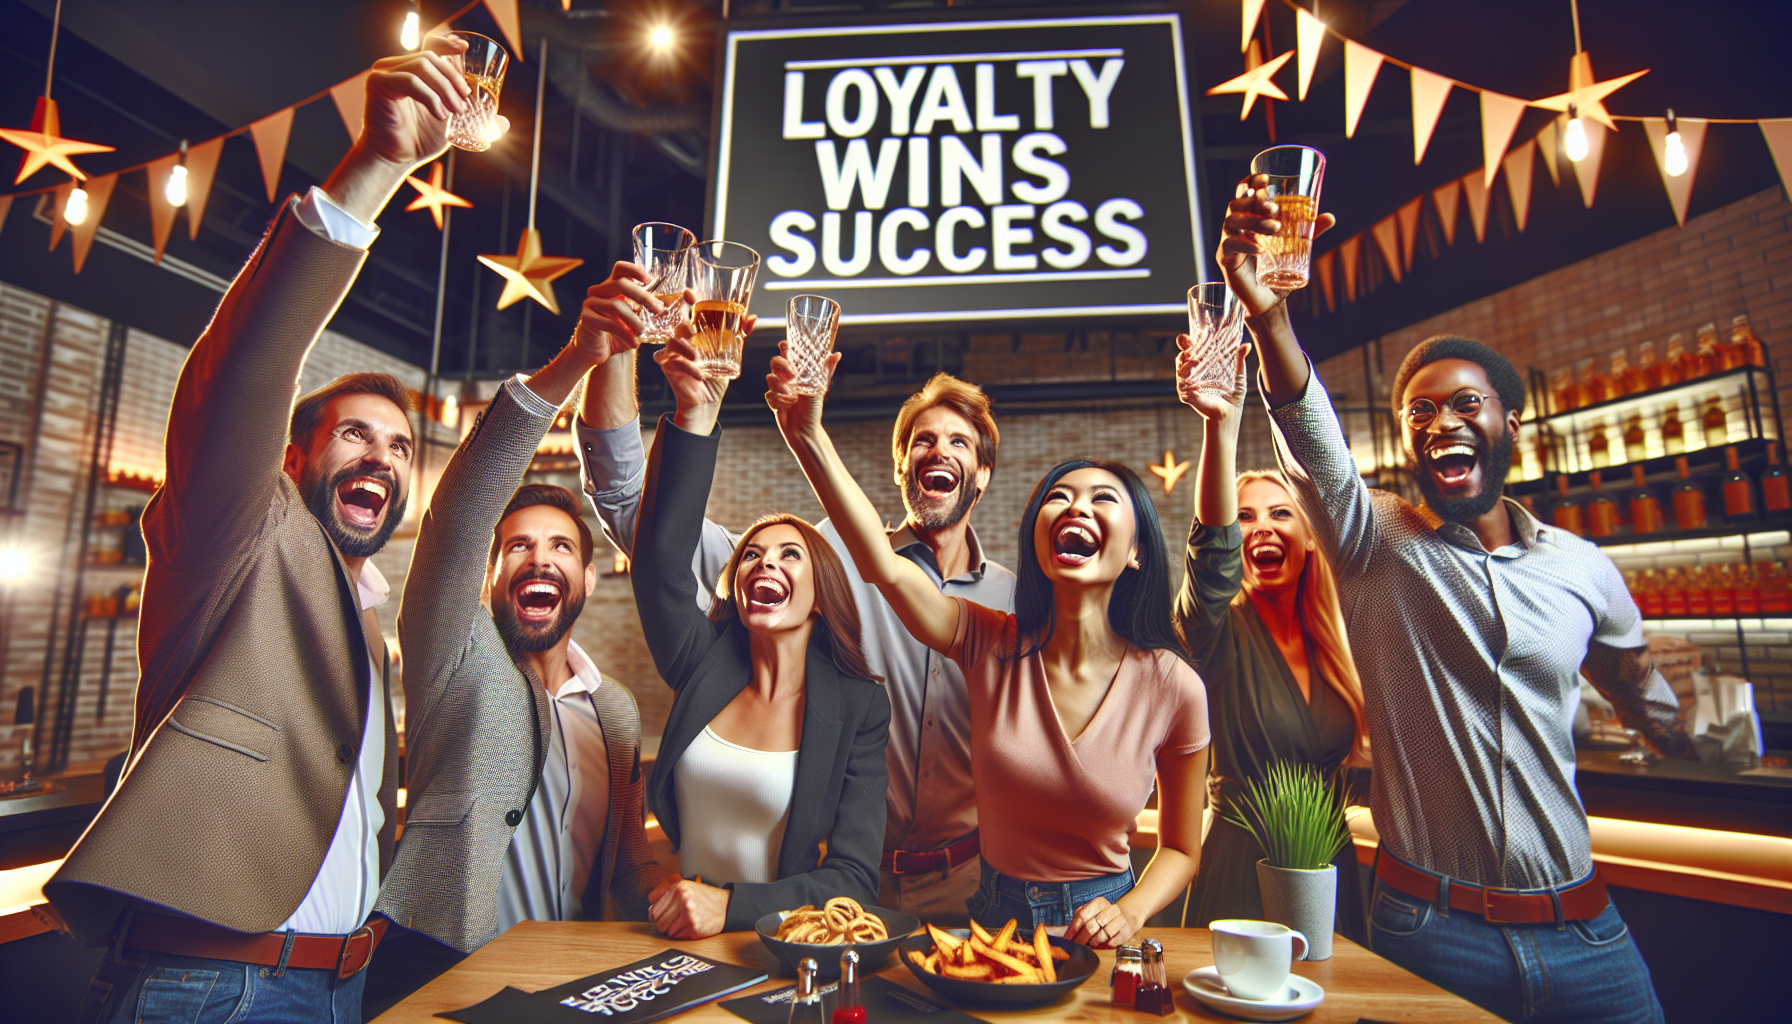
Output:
[767, 355, 1208, 947]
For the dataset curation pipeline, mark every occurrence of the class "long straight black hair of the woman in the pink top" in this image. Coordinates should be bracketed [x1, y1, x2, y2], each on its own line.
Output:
[1014, 459, 1186, 660]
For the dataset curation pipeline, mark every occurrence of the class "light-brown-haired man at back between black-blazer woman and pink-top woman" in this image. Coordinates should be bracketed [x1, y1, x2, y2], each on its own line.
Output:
[577, 340, 1014, 924]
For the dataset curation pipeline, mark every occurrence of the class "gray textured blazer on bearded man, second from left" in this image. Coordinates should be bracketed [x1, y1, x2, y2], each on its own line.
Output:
[375, 382, 659, 952]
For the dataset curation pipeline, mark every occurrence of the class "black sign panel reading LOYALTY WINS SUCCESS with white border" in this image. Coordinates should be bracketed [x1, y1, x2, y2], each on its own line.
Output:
[713, 14, 1204, 326]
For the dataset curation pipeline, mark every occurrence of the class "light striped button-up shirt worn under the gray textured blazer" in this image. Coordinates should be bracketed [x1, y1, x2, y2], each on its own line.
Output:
[498, 640, 609, 933]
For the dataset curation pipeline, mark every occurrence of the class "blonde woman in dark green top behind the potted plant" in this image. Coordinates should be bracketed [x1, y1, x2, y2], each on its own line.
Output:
[1176, 337, 1369, 942]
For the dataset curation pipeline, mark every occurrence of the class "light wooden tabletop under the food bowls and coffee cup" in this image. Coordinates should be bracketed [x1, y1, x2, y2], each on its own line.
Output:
[376, 922, 1498, 1024]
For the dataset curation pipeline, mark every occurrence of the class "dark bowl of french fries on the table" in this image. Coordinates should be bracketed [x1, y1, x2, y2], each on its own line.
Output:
[898, 920, 1100, 1004]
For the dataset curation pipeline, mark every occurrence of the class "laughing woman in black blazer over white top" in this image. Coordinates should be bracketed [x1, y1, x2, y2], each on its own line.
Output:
[629, 390, 891, 938]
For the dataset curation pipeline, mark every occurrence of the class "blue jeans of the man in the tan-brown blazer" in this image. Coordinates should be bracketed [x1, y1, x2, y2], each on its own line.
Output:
[81, 949, 367, 1024]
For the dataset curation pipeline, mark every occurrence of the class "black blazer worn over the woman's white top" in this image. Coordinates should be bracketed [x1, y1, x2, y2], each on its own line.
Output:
[629, 418, 891, 931]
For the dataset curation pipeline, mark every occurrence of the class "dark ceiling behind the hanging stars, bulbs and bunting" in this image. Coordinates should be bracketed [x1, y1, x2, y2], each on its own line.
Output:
[0, 0, 1792, 377]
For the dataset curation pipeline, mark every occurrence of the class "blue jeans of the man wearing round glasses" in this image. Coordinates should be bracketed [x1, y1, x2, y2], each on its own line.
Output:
[1369, 879, 1663, 1024]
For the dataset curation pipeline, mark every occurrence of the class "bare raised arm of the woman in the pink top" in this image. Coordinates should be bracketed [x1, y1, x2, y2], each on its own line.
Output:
[765, 343, 959, 653]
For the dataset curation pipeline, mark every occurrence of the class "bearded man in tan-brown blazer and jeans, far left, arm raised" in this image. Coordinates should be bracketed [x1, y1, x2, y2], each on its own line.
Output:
[45, 38, 470, 1022]
